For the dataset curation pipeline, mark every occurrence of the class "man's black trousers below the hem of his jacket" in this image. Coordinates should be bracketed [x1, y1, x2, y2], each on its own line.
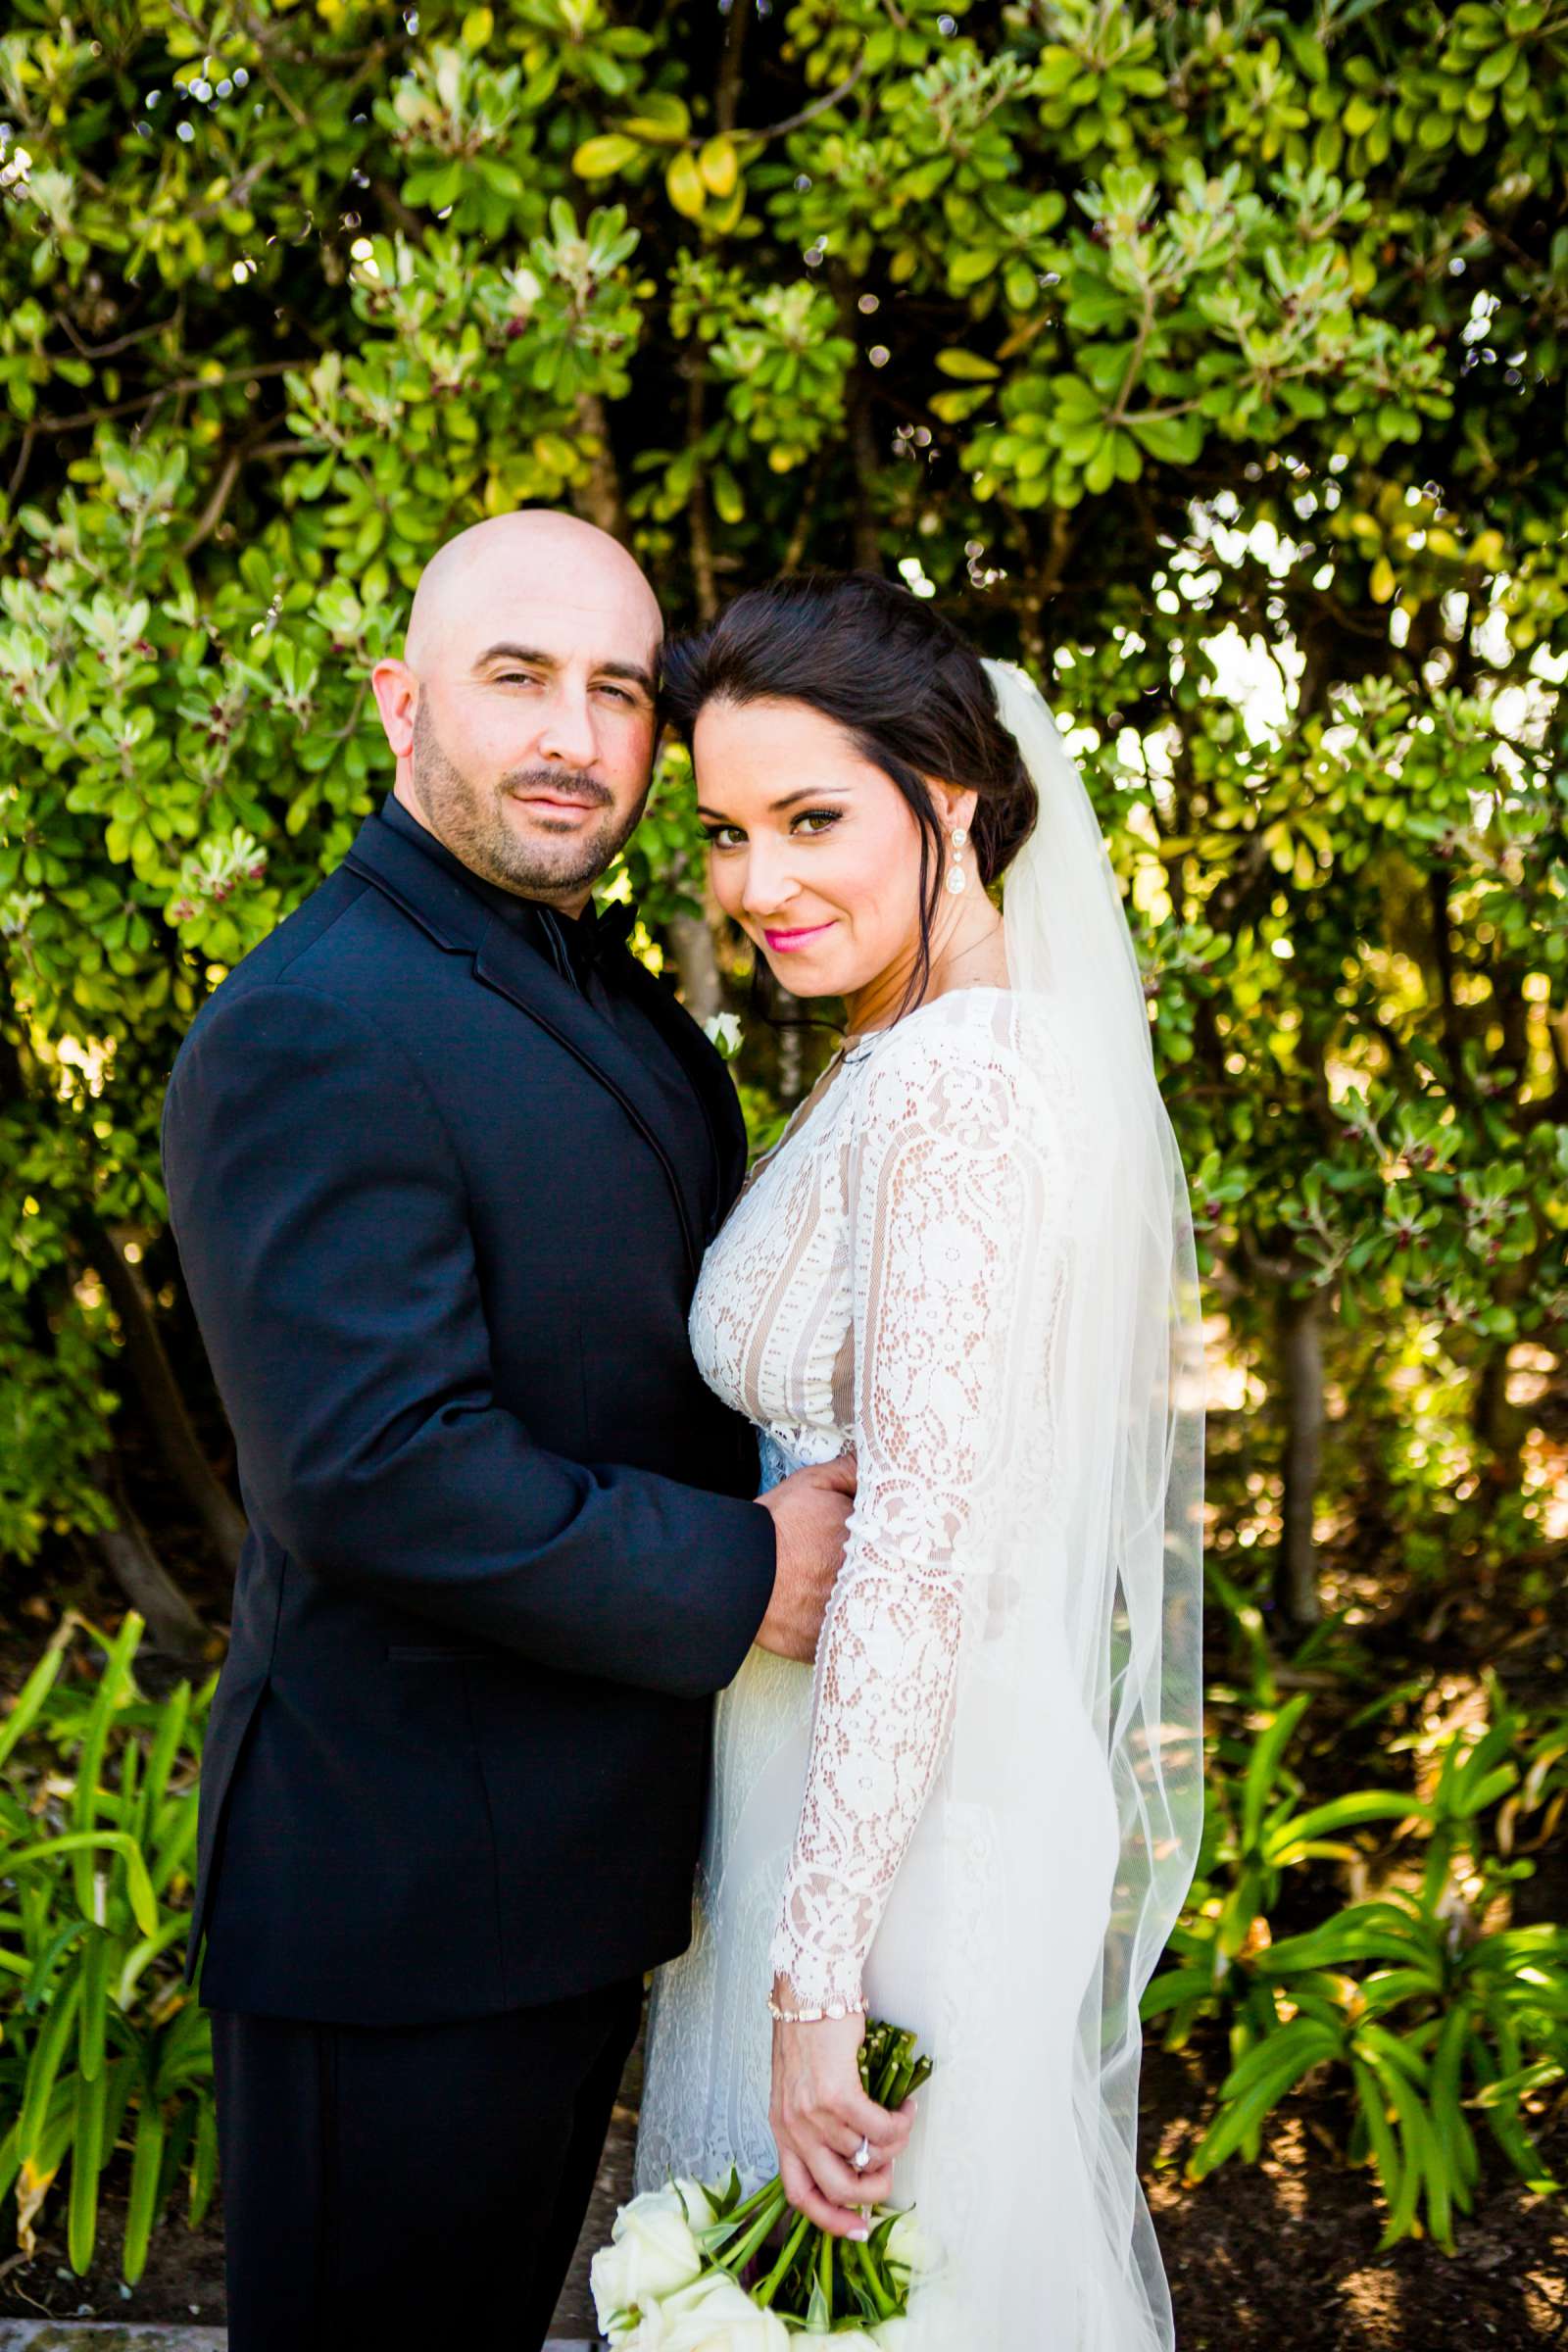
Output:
[212, 1978, 642, 2352]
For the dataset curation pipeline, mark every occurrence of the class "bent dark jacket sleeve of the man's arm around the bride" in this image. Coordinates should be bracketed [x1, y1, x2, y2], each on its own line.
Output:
[165, 983, 776, 1695]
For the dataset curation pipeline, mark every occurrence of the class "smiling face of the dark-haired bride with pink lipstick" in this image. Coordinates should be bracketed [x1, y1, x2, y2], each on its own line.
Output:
[691, 701, 973, 998]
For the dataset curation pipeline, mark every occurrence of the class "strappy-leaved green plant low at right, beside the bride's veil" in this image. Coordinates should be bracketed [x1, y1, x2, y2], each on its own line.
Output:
[1143, 1687, 1568, 2251]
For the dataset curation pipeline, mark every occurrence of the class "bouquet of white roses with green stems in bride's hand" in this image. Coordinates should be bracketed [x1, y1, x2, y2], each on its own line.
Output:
[590, 2018, 931, 2352]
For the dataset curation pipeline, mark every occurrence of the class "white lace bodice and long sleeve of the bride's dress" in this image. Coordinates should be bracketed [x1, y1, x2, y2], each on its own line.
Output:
[691, 990, 1081, 2009]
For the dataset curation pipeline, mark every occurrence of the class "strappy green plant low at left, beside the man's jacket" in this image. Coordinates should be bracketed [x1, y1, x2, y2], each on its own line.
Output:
[0, 1616, 217, 2283]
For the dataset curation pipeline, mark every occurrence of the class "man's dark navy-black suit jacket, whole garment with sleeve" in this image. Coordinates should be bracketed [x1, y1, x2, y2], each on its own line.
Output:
[165, 816, 773, 2023]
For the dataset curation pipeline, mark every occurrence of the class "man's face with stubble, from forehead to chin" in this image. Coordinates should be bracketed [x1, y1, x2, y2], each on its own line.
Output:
[399, 566, 659, 907]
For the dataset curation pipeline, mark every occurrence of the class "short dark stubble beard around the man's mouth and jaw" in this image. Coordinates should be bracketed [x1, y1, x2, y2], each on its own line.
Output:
[409, 701, 651, 901]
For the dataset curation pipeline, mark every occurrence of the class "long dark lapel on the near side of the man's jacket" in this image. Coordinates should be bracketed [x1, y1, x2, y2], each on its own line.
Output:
[343, 816, 705, 1272]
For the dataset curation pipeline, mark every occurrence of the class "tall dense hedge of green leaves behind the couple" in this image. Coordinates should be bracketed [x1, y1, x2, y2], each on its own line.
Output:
[0, 0, 1568, 1571]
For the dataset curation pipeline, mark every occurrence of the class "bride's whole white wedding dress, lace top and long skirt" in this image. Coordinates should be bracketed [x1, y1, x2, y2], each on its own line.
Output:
[637, 988, 1168, 2352]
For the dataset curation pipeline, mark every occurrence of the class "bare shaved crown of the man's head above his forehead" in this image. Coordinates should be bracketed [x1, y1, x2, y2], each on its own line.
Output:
[402, 506, 662, 677]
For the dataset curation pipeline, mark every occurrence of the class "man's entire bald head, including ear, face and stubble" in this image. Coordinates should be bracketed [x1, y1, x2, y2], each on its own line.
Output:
[371, 506, 662, 912]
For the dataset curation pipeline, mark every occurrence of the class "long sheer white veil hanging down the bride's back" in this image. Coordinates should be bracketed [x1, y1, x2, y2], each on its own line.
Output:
[909, 661, 1203, 2352]
